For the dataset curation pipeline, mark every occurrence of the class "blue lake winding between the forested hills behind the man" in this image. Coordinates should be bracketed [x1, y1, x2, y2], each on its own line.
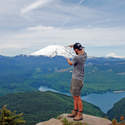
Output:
[39, 87, 125, 113]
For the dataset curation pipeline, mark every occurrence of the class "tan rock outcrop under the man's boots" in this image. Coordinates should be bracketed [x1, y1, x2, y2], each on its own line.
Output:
[36, 114, 112, 125]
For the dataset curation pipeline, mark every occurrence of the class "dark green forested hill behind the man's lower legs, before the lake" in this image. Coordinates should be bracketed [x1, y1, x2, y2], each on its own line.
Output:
[0, 92, 105, 125]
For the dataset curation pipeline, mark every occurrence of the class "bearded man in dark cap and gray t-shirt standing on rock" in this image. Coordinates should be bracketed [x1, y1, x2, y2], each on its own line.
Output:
[67, 43, 87, 121]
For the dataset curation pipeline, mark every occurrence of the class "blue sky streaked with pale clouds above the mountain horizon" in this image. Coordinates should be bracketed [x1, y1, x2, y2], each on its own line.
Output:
[0, 0, 125, 56]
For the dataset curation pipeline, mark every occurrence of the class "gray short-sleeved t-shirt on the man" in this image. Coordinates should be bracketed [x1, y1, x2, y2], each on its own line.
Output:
[72, 52, 87, 80]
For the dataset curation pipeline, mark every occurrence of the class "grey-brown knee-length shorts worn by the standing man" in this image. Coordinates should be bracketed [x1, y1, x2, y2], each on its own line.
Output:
[70, 78, 83, 96]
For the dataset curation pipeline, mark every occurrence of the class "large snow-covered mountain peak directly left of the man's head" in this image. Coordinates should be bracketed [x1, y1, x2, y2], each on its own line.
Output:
[30, 45, 75, 58]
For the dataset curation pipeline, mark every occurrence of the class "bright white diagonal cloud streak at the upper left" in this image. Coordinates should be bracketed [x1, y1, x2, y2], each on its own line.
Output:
[21, 0, 52, 14]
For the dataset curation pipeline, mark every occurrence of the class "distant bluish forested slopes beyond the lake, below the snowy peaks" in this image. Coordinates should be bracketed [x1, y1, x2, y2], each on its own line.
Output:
[0, 55, 125, 95]
